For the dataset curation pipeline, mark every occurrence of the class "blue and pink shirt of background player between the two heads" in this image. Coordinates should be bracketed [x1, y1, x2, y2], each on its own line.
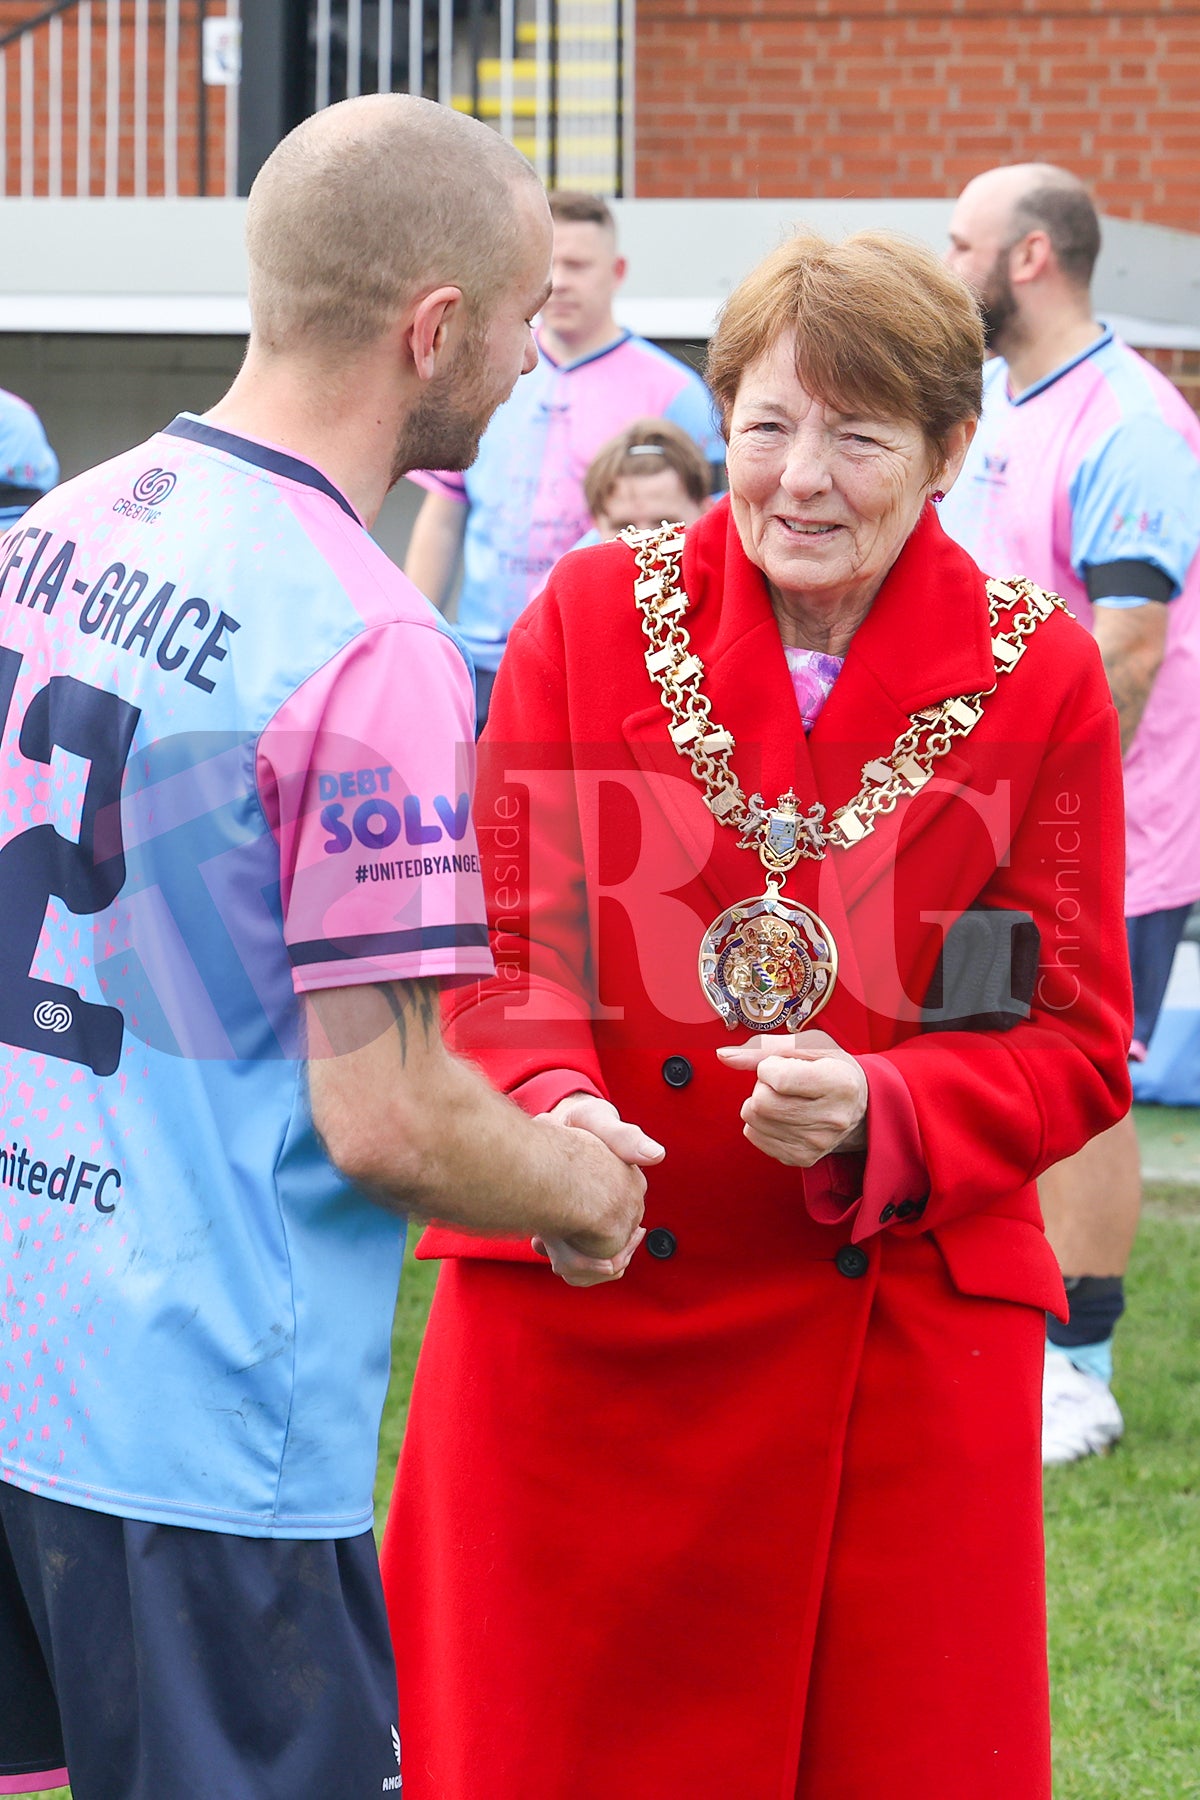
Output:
[410, 331, 725, 671]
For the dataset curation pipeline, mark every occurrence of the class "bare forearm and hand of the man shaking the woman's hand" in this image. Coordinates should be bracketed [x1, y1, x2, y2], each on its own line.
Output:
[309, 981, 642, 1256]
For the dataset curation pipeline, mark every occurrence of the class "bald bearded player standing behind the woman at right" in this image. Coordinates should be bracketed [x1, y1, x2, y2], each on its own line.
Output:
[941, 162, 1200, 1463]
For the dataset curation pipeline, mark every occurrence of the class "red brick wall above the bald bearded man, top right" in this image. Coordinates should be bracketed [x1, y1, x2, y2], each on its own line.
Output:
[635, 0, 1200, 230]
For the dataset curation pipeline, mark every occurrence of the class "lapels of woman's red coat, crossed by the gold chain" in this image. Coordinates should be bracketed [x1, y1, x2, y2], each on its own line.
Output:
[622, 508, 995, 1030]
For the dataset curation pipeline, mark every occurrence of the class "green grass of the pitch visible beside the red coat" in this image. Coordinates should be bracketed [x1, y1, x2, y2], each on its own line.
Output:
[32, 1184, 1200, 1800]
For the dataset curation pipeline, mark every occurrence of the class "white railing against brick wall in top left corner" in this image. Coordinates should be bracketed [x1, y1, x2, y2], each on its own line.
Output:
[0, 0, 237, 198]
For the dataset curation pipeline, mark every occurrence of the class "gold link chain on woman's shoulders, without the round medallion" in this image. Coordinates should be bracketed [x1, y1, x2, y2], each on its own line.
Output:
[621, 524, 1069, 878]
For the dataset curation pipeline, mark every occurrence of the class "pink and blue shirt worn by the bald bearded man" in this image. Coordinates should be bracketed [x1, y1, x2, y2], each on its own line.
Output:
[939, 331, 1200, 918]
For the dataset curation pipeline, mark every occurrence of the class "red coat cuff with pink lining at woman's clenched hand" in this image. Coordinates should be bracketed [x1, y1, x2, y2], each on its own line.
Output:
[804, 1057, 930, 1244]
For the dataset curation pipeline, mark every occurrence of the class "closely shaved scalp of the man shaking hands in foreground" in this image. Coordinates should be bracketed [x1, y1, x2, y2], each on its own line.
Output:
[246, 94, 540, 355]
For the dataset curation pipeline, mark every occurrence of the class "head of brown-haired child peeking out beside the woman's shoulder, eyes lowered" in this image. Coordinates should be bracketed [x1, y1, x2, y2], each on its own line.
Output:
[579, 419, 709, 544]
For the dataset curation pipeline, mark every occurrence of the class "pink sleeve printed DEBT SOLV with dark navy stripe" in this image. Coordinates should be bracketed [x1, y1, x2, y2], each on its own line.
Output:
[257, 621, 493, 994]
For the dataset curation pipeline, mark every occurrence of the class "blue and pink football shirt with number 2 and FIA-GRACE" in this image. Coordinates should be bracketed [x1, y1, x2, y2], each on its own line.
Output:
[0, 416, 491, 1537]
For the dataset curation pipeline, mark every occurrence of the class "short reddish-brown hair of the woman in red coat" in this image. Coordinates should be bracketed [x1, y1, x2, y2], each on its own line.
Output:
[707, 230, 984, 468]
